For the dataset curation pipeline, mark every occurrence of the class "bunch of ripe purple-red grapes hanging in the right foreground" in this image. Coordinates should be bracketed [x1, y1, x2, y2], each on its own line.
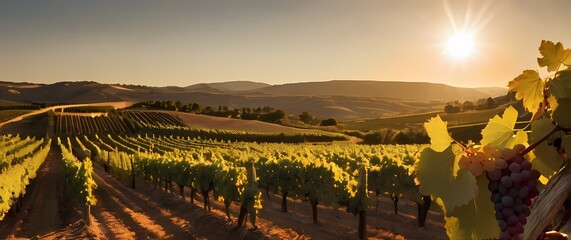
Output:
[487, 145, 540, 240]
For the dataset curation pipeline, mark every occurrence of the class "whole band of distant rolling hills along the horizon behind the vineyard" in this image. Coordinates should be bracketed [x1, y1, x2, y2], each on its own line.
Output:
[0, 81, 506, 119]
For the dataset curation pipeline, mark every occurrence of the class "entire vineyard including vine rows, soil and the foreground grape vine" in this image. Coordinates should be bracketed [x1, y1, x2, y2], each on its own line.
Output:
[0, 41, 571, 239]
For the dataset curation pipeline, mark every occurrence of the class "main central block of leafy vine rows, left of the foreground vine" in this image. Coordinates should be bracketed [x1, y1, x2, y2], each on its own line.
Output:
[67, 135, 431, 238]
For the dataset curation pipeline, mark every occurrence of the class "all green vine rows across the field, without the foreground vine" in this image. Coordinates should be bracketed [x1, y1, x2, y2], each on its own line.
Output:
[0, 102, 442, 238]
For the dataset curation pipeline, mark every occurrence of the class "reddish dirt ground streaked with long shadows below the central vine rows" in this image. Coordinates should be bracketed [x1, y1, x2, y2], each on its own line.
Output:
[89, 166, 447, 239]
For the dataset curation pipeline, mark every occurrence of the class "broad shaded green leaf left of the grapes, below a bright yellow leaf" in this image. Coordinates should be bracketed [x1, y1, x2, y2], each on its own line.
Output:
[417, 145, 478, 211]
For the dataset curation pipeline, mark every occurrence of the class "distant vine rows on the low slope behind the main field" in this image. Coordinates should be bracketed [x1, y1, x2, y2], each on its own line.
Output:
[48, 110, 347, 143]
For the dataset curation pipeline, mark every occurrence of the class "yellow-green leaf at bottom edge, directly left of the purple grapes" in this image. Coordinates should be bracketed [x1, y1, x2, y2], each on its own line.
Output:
[445, 175, 500, 239]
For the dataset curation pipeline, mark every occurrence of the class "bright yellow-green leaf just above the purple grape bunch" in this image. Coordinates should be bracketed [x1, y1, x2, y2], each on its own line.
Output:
[481, 106, 527, 148]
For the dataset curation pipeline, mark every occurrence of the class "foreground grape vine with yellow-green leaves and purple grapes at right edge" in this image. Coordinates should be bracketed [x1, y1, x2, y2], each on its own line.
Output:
[417, 40, 571, 239]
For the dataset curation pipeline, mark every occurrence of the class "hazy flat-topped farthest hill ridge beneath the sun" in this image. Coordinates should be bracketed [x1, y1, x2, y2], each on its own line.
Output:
[252, 80, 507, 101]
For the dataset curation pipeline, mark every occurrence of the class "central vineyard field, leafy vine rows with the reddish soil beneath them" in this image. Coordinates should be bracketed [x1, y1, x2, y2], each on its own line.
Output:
[0, 130, 445, 239]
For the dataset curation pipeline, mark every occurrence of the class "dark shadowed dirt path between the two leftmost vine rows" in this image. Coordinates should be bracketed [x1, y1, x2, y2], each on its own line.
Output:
[0, 149, 79, 239]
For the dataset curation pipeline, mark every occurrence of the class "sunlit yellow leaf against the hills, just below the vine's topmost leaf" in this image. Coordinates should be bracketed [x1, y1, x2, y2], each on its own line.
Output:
[508, 70, 545, 115]
